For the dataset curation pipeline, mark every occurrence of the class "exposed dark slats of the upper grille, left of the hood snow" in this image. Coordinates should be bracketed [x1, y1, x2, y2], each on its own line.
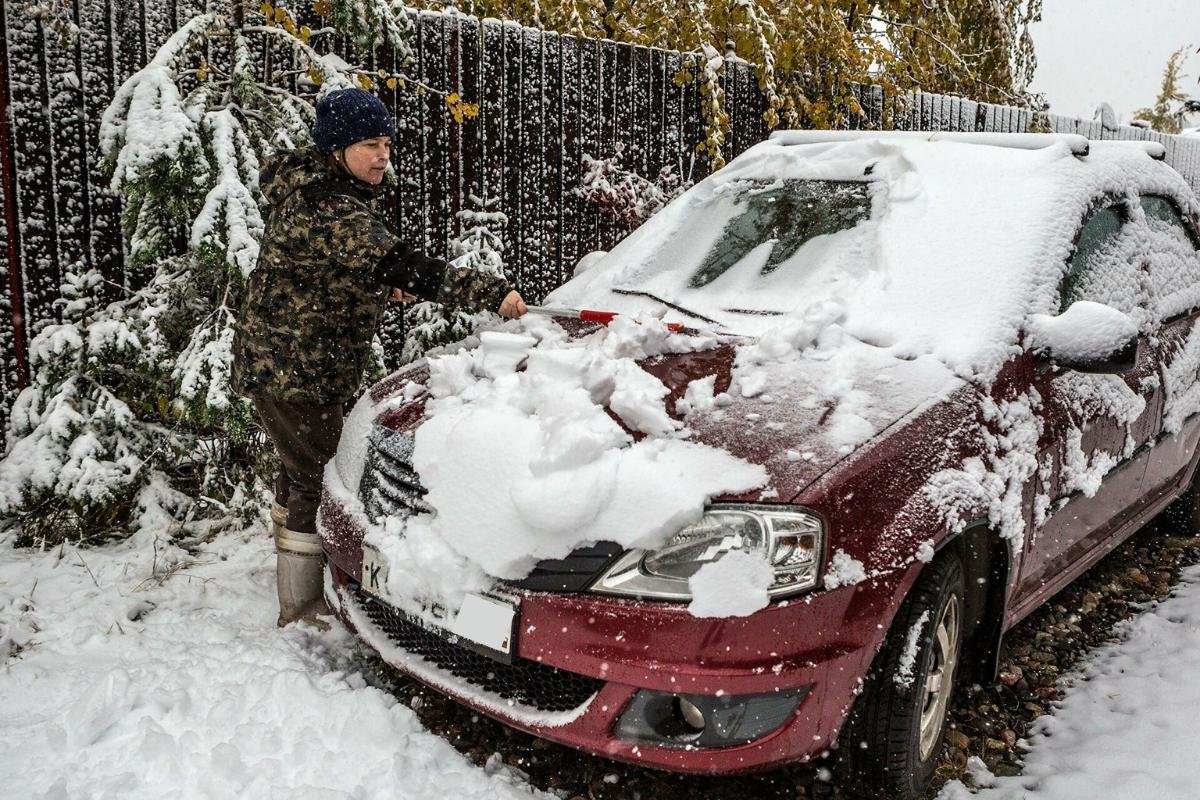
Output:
[359, 425, 430, 522]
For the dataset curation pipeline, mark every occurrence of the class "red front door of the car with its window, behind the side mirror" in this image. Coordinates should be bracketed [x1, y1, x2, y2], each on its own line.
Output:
[1014, 199, 1162, 604]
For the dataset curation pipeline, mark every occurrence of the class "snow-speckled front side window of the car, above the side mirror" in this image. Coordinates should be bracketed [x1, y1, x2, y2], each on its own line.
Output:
[1060, 203, 1146, 319]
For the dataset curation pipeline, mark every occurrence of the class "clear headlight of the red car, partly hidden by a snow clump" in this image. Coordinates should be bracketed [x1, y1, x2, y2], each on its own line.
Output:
[592, 505, 824, 600]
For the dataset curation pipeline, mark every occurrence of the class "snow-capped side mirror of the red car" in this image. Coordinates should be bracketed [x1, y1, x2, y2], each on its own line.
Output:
[1026, 300, 1138, 374]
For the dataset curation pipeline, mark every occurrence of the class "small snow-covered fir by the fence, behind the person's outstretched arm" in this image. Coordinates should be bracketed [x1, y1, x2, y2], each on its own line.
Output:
[400, 194, 508, 363]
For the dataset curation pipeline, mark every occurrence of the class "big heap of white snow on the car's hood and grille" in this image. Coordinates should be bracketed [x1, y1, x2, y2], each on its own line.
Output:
[335, 318, 766, 613]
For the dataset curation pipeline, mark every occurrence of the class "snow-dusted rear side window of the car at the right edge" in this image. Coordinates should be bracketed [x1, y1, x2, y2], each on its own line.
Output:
[1140, 196, 1200, 320]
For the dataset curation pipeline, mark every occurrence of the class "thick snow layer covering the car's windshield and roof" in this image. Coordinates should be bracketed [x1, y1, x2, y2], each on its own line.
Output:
[548, 138, 1193, 380]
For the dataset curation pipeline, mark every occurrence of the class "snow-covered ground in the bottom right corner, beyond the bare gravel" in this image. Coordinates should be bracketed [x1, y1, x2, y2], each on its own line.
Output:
[938, 566, 1200, 800]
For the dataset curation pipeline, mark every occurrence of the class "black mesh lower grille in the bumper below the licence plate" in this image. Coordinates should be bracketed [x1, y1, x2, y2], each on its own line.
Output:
[354, 584, 604, 711]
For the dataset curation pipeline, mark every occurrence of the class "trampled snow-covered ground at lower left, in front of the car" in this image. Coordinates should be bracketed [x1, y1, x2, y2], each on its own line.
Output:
[0, 530, 548, 800]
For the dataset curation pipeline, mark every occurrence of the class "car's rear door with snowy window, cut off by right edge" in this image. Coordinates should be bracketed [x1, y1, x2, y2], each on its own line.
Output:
[1139, 194, 1200, 494]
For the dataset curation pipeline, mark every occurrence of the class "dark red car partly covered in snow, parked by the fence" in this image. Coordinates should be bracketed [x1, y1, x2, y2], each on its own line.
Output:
[319, 132, 1200, 798]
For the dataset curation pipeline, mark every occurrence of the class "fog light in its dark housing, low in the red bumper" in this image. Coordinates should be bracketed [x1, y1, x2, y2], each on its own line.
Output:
[614, 686, 809, 747]
